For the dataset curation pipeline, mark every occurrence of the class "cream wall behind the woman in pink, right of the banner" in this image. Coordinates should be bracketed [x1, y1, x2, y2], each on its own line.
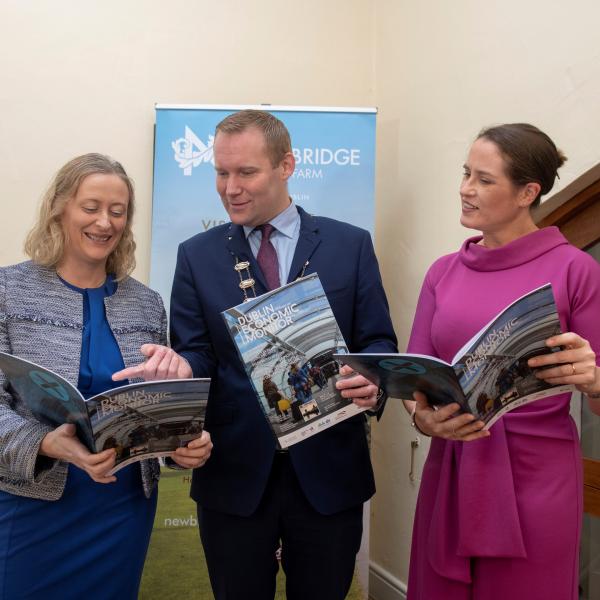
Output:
[371, 0, 600, 582]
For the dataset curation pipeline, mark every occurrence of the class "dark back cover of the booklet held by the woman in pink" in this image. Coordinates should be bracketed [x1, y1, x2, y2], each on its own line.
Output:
[336, 354, 468, 410]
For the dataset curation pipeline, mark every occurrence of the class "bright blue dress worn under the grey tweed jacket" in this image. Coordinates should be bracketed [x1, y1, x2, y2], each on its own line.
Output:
[0, 277, 156, 600]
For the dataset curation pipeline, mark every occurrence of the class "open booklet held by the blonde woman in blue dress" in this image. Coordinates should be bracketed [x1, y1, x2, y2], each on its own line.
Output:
[0, 352, 210, 474]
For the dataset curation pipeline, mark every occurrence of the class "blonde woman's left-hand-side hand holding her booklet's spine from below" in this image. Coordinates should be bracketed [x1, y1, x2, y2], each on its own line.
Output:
[39, 423, 117, 483]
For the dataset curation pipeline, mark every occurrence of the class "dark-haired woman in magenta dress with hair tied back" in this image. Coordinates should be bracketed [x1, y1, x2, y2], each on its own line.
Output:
[406, 124, 600, 600]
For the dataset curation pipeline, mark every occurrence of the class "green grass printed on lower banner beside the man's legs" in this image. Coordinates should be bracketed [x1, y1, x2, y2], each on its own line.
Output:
[139, 469, 363, 600]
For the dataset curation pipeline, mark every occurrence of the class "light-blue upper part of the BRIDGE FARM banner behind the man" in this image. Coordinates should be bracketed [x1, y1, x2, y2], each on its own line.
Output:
[150, 104, 376, 304]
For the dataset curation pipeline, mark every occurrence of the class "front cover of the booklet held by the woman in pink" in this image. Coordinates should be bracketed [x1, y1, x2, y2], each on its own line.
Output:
[454, 284, 572, 427]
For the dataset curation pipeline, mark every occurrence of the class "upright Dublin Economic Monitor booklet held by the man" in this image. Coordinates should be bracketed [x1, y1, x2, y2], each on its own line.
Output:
[222, 274, 366, 448]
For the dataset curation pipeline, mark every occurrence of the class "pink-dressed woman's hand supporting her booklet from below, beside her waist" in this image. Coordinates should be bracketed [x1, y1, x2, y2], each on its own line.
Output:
[413, 392, 490, 442]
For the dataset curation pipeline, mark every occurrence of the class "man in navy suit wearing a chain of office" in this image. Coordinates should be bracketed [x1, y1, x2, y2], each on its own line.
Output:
[171, 110, 396, 600]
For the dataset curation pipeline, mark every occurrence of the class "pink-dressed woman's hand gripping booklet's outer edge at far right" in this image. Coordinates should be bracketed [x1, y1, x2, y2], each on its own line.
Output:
[527, 332, 600, 394]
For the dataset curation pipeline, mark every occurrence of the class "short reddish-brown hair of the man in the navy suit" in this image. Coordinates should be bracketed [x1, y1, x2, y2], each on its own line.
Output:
[215, 109, 292, 167]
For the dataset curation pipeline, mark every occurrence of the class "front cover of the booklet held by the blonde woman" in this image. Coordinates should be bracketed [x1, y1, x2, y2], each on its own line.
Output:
[87, 379, 210, 473]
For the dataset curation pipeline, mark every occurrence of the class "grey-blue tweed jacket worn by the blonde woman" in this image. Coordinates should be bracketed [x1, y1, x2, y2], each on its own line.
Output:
[0, 261, 167, 500]
